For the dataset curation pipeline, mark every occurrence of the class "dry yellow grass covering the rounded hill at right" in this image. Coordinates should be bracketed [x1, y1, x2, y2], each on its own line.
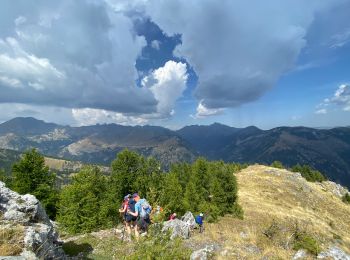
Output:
[193, 165, 350, 259]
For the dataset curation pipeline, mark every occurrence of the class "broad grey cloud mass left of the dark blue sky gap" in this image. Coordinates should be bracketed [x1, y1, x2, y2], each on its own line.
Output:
[0, 0, 157, 113]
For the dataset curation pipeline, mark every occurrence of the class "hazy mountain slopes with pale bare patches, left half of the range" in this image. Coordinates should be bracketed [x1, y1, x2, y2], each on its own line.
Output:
[0, 118, 195, 168]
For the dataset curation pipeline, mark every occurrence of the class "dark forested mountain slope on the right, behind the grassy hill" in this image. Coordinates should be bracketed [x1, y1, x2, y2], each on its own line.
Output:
[178, 126, 350, 187]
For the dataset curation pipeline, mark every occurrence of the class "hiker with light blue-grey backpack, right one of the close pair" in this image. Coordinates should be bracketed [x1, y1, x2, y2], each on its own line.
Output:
[127, 193, 152, 239]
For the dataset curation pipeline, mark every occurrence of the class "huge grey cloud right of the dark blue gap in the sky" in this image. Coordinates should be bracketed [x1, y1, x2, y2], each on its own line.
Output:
[141, 0, 337, 110]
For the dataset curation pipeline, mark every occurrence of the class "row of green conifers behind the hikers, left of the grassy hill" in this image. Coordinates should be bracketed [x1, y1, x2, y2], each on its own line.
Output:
[0, 149, 245, 233]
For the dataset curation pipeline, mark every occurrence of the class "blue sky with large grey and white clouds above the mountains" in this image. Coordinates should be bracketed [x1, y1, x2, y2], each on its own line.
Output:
[0, 0, 350, 129]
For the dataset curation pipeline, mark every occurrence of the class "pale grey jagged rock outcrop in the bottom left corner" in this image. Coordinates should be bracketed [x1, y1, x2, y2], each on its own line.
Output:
[0, 182, 66, 259]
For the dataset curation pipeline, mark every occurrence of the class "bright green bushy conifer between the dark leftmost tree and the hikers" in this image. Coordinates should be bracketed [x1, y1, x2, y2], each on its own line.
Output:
[58, 166, 113, 233]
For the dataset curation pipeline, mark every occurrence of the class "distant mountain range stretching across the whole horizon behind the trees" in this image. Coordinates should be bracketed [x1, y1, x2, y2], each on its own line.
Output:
[0, 117, 350, 187]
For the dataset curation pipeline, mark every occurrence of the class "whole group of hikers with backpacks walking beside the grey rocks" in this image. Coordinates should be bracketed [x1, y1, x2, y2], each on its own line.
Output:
[119, 193, 204, 240]
